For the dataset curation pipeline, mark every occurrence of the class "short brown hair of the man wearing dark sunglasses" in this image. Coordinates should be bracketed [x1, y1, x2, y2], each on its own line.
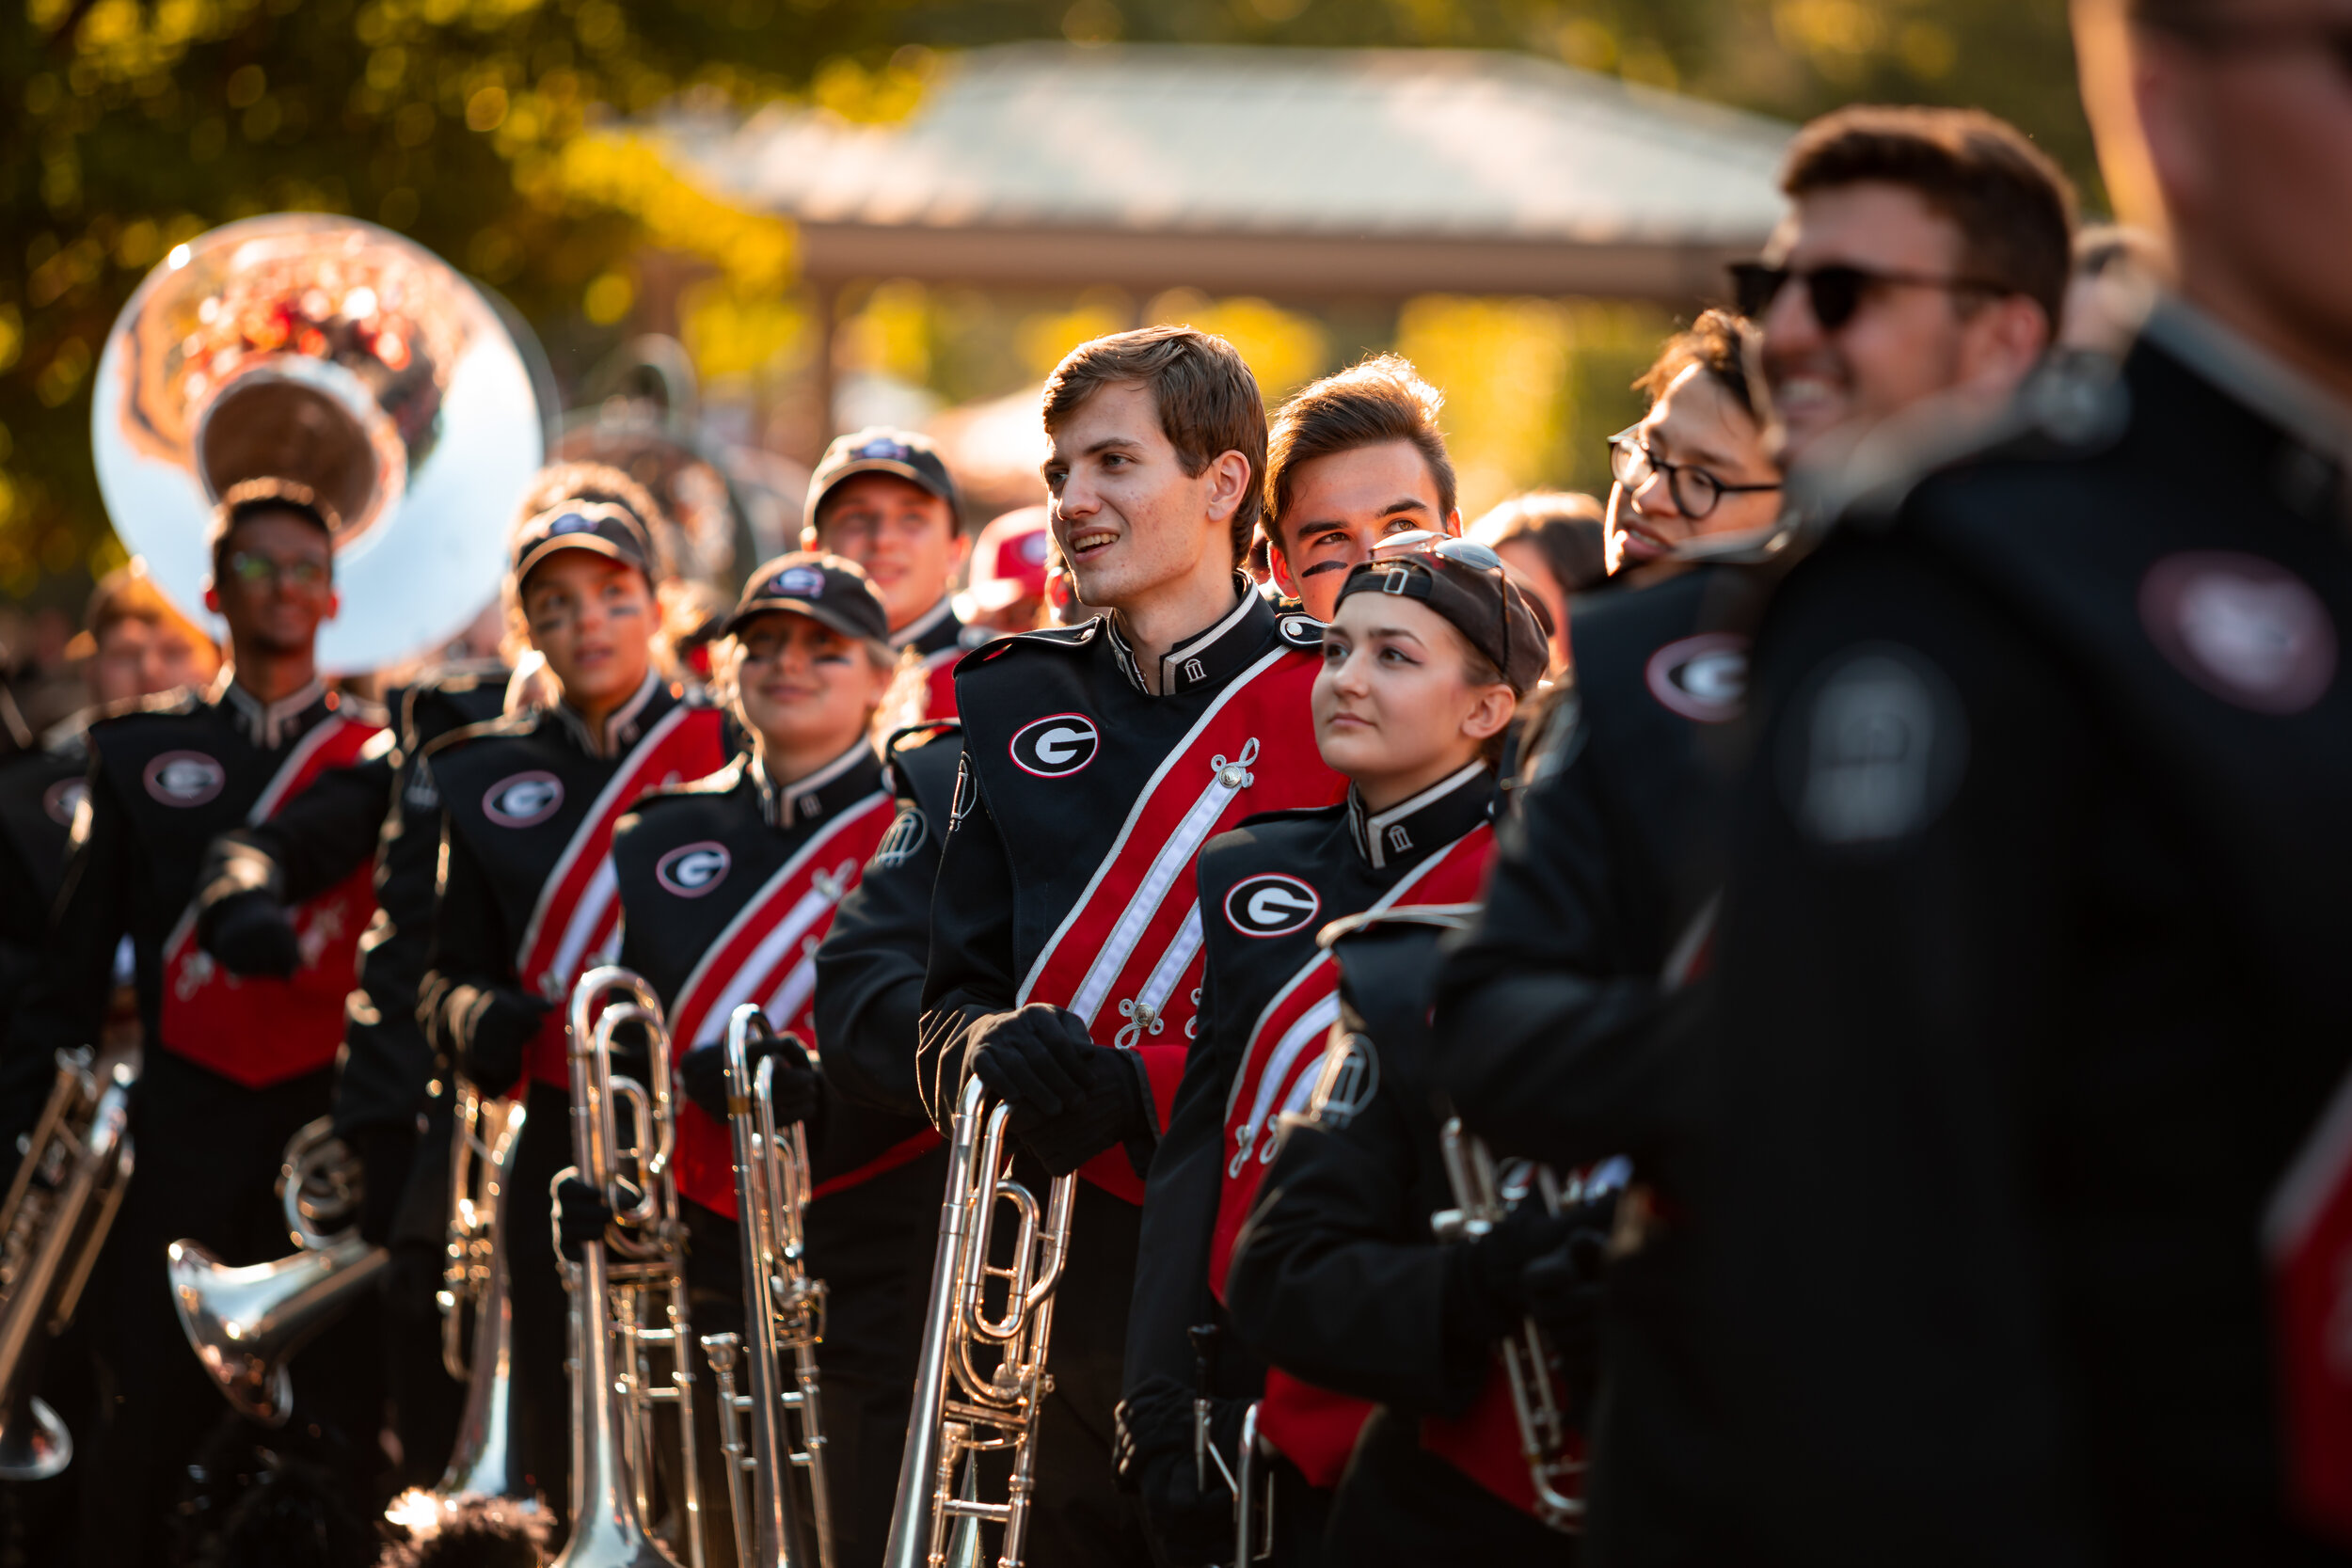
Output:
[1781, 103, 2074, 334]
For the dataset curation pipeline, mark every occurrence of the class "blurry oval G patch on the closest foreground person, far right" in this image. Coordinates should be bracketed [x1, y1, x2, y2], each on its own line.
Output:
[2140, 550, 2336, 717]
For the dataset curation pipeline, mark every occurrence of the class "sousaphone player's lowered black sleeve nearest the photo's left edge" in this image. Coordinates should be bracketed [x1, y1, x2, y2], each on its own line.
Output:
[0, 745, 139, 1133]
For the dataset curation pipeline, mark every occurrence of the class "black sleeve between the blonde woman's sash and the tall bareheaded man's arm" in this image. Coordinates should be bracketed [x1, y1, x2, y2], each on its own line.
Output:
[817, 797, 941, 1117]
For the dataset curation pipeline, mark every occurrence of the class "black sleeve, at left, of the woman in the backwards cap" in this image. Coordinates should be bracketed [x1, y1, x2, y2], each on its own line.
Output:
[1127, 971, 1235, 1392]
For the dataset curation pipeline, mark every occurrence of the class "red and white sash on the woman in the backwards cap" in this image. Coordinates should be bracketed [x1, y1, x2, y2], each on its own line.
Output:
[1209, 846, 1494, 1486]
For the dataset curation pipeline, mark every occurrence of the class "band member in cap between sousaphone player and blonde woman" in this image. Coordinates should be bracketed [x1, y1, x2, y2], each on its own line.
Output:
[412, 496, 727, 1512]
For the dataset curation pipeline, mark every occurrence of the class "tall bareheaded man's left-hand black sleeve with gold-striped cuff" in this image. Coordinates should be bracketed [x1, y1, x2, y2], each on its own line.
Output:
[915, 780, 1021, 1131]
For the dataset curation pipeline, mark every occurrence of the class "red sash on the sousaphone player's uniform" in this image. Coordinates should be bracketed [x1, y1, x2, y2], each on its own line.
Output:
[163, 715, 384, 1088]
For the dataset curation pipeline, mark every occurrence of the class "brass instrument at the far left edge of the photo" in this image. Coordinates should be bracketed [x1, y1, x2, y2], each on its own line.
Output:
[0, 1049, 136, 1481]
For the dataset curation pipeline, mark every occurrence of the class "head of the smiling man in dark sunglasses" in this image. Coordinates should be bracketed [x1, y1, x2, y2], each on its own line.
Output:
[1734, 108, 2073, 472]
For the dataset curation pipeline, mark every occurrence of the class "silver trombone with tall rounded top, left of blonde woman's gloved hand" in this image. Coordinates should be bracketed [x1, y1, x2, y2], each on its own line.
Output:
[555, 964, 704, 1568]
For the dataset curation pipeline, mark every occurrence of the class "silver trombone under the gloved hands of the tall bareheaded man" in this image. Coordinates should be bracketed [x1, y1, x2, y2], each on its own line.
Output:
[882, 1079, 1077, 1568]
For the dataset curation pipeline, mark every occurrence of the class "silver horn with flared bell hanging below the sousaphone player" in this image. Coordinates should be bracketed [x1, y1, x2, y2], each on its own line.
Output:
[165, 1117, 390, 1427]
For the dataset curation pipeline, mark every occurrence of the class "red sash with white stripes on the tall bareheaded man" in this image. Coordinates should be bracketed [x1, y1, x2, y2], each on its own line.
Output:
[1014, 646, 1348, 1204]
